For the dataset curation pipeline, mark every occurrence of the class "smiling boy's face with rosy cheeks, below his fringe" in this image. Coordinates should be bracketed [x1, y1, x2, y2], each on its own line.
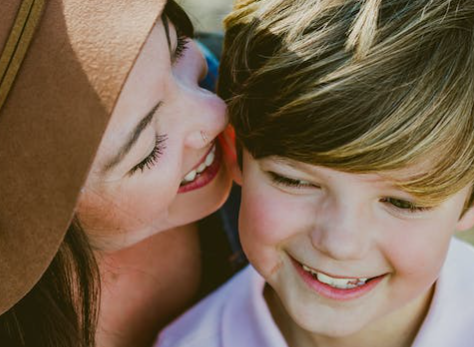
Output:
[239, 151, 473, 337]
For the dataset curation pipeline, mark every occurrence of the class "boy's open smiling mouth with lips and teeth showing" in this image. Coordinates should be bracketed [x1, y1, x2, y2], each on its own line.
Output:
[290, 257, 387, 301]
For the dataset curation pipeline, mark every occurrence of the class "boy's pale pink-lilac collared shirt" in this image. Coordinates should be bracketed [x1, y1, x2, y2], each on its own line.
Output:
[155, 239, 474, 347]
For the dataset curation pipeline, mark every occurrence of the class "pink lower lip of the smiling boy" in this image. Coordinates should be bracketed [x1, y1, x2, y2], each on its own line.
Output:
[291, 258, 386, 301]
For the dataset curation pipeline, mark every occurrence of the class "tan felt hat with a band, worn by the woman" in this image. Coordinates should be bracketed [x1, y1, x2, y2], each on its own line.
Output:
[0, 0, 165, 314]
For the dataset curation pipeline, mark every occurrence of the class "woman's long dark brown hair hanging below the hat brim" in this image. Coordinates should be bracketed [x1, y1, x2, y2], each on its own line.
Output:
[0, 219, 100, 347]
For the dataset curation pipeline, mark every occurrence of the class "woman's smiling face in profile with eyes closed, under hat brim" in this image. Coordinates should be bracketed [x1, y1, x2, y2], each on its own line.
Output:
[77, 12, 231, 251]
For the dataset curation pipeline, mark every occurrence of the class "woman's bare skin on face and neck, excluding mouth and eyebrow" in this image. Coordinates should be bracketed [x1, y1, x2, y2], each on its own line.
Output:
[77, 8, 231, 347]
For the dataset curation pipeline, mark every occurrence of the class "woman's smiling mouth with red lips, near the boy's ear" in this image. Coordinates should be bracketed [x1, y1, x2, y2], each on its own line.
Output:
[178, 143, 222, 193]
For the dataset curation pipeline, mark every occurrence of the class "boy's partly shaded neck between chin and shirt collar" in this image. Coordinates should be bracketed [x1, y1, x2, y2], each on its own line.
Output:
[264, 284, 434, 347]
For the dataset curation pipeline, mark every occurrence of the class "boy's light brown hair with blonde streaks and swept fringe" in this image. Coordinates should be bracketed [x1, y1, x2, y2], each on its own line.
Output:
[219, 0, 474, 206]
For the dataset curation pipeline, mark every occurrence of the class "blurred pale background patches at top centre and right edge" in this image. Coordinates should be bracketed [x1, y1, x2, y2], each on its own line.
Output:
[177, 0, 474, 244]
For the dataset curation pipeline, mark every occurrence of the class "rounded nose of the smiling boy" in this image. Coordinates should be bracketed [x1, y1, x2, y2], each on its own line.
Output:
[311, 202, 373, 261]
